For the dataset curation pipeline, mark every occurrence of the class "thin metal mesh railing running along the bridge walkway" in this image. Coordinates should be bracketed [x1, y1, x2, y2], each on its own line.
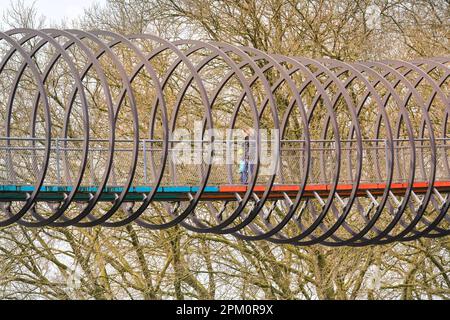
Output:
[0, 137, 450, 186]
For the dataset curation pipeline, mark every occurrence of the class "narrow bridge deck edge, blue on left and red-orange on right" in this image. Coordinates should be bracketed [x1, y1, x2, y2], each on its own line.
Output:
[0, 181, 450, 202]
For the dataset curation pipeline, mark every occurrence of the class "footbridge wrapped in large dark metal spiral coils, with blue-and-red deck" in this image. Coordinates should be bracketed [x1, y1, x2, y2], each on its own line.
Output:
[0, 29, 450, 246]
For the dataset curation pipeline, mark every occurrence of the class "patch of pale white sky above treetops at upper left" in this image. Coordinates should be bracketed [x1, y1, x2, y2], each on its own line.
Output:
[0, 0, 106, 23]
